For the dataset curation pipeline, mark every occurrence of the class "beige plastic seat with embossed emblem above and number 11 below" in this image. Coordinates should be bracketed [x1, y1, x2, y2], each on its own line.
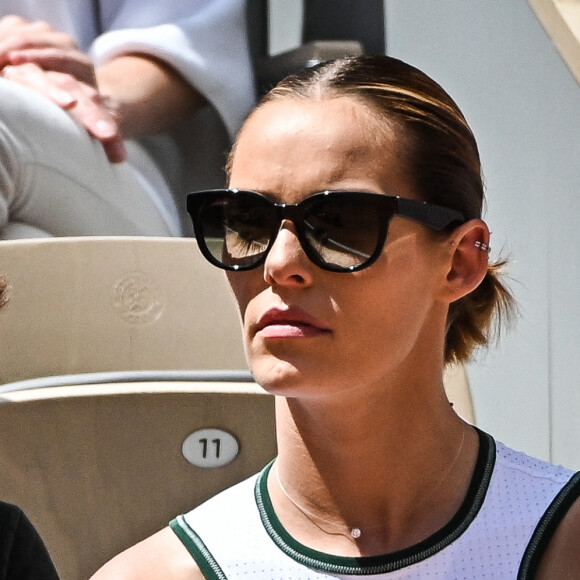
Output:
[0, 237, 268, 580]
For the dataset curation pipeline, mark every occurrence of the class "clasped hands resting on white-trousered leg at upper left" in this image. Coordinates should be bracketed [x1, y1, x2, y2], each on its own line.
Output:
[0, 16, 127, 163]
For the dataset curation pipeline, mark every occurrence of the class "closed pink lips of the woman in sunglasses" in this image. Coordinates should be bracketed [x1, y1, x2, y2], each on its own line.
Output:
[257, 307, 330, 338]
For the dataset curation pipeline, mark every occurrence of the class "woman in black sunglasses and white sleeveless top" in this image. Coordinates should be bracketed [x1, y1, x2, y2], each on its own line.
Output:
[90, 56, 580, 579]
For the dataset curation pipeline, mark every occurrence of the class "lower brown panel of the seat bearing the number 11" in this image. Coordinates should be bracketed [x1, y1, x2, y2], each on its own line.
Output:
[0, 382, 276, 580]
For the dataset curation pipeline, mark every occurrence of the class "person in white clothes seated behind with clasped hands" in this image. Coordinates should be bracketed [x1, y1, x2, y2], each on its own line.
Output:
[0, 0, 254, 238]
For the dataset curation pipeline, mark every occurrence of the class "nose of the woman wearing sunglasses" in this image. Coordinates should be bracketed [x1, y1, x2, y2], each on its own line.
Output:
[264, 220, 316, 286]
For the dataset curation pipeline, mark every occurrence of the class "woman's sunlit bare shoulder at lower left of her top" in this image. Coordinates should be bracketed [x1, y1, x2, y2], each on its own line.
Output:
[91, 527, 204, 580]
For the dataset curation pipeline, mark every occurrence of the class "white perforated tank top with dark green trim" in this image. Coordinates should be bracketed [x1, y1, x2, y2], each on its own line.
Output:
[170, 431, 580, 580]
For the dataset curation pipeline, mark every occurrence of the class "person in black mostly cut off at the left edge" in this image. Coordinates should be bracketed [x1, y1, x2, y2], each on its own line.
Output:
[0, 276, 58, 580]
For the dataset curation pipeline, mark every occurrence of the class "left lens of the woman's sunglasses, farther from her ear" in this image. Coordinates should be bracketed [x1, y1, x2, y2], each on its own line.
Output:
[200, 193, 276, 269]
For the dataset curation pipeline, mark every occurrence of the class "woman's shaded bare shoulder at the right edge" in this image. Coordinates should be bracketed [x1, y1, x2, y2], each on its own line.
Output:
[535, 499, 580, 580]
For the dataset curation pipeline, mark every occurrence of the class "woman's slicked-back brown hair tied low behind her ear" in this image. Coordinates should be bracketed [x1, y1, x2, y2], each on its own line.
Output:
[228, 55, 513, 362]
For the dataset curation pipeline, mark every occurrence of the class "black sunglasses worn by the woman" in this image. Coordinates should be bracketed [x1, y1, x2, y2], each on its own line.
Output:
[187, 189, 465, 272]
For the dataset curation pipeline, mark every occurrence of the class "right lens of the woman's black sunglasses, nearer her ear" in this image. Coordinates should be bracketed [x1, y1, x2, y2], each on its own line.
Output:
[304, 194, 385, 271]
